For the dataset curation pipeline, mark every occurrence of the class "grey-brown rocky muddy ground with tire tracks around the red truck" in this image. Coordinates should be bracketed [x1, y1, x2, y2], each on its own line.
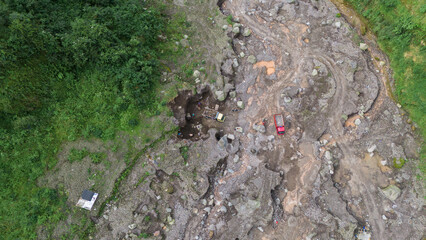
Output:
[49, 0, 425, 240]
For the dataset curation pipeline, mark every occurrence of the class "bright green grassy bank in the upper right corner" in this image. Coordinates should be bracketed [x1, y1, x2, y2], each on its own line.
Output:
[345, 0, 426, 174]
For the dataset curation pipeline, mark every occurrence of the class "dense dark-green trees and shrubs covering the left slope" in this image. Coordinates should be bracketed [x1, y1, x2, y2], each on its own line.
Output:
[0, 0, 185, 239]
